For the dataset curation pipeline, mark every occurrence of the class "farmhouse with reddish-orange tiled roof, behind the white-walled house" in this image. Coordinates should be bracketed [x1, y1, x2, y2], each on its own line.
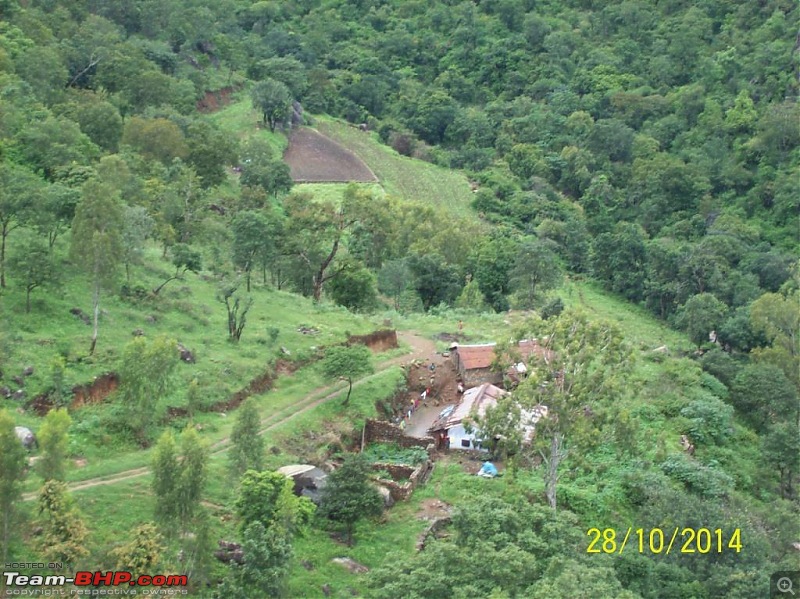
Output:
[450, 339, 552, 387]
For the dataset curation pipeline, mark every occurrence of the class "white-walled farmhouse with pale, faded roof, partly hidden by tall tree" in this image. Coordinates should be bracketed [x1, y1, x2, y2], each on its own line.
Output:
[429, 383, 547, 451]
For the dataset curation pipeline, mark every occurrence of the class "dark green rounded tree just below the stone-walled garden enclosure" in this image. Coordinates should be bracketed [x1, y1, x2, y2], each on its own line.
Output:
[319, 454, 383, 545]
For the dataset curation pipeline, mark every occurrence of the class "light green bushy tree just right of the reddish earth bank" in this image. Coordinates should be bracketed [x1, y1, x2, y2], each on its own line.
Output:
[119, 335, 179, 443]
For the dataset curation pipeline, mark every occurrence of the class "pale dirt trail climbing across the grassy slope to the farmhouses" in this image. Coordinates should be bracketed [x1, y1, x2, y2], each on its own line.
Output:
[22, 331, 436, 501]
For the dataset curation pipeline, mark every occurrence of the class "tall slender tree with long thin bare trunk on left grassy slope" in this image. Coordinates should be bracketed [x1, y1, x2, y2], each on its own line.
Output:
[70, 179, 123, 355]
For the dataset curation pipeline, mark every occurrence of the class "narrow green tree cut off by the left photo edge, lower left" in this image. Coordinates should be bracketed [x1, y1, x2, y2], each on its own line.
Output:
[0, 410, 27, 563]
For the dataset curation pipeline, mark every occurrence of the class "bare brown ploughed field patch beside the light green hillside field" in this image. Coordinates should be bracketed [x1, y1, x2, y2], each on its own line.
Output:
[283, 127, 378, 183]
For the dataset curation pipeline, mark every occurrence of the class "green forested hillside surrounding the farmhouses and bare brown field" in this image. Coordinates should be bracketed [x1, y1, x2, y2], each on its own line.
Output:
[0, 0, 800, 599]
